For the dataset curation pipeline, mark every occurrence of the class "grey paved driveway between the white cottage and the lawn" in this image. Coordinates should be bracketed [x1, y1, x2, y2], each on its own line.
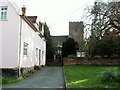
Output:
[3, 66, 65, 88]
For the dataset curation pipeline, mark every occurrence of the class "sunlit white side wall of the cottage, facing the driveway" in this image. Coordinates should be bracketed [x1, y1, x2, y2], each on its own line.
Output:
[20, 19, 46, 67]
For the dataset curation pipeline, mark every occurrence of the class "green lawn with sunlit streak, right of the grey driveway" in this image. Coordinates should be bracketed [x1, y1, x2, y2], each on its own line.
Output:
[64, 65, 120, 88]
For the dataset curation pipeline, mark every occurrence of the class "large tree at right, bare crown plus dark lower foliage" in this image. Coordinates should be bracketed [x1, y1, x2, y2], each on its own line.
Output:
[86, 1, 120, 55]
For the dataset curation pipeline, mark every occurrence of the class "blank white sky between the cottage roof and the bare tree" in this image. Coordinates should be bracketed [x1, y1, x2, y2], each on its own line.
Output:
[13, 0, 94, 35]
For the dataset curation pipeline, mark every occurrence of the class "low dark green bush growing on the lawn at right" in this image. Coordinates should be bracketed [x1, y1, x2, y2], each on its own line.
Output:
[100, 71, 120, 82]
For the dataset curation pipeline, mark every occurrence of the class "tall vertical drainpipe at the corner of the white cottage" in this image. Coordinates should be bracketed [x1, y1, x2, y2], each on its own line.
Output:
[18, 16, 22, 78]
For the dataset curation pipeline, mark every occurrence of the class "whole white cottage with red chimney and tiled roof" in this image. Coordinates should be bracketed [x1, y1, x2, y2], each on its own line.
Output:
[0, 0, 46, 75]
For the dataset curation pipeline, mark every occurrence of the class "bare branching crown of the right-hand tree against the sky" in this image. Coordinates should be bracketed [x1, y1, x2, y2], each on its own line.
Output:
[86, 1, 120, 38]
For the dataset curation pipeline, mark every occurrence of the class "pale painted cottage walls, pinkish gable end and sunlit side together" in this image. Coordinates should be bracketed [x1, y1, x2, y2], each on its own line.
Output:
[0, 0, 46, 68]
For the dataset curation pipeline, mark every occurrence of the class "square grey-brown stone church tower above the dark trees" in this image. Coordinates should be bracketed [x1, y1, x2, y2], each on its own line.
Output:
[69, 21, 84, 51]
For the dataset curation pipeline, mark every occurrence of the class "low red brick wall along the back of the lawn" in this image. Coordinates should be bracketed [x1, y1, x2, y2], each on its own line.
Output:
[63, 58, 120, 65]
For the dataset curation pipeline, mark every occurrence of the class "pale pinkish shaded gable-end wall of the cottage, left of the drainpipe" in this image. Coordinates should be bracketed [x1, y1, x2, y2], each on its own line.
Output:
[0, 0, 20, 68]
